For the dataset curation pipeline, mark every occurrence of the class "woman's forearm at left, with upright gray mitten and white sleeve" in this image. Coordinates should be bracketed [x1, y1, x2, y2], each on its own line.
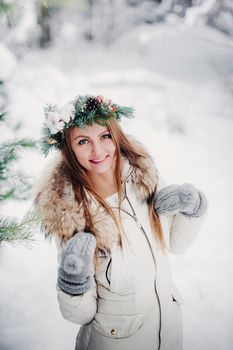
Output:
[56, 232, 97, 325]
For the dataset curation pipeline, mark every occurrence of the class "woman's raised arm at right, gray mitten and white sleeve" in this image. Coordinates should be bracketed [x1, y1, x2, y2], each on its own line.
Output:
[155, 175, 208, 254]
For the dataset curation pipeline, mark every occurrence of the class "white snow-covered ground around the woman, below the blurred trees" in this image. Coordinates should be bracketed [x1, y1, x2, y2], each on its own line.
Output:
[0, 25, 233, 350]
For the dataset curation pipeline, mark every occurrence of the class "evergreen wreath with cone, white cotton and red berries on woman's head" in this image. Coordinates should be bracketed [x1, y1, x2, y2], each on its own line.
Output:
[41, 95, 134, 156]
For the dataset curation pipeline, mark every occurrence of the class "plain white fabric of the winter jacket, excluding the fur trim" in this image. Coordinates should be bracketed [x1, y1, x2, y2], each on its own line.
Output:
[57, 161, 206, 350]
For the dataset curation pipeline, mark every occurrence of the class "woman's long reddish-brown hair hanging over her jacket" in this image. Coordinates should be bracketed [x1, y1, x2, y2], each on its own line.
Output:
[61, 119, 166, 249]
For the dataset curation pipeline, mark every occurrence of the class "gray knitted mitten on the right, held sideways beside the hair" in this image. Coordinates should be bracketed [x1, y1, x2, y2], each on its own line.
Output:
[154, 183, 207, 218]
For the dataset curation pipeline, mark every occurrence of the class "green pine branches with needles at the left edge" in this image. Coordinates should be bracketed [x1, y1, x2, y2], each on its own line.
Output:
[0, 112, 39, 245]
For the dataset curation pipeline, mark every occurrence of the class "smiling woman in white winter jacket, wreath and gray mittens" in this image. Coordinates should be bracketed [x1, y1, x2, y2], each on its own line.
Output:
[35, 96, 207, 350]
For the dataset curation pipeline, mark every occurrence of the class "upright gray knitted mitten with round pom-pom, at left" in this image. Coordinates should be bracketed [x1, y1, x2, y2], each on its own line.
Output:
[57, 231, 96, 295]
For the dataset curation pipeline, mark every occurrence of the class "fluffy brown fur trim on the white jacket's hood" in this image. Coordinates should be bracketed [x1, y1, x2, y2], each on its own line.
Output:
[35, 138, 158, 250]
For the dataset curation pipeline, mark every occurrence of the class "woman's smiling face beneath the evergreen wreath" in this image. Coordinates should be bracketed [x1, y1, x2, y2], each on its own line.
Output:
[71, 124, 116, 174]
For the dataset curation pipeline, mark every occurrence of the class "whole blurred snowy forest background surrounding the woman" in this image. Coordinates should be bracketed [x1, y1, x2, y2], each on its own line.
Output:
[0, 0, 233, 350]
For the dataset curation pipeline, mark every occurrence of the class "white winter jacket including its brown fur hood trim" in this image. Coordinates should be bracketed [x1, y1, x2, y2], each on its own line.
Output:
[36, 139, 206, 350]
